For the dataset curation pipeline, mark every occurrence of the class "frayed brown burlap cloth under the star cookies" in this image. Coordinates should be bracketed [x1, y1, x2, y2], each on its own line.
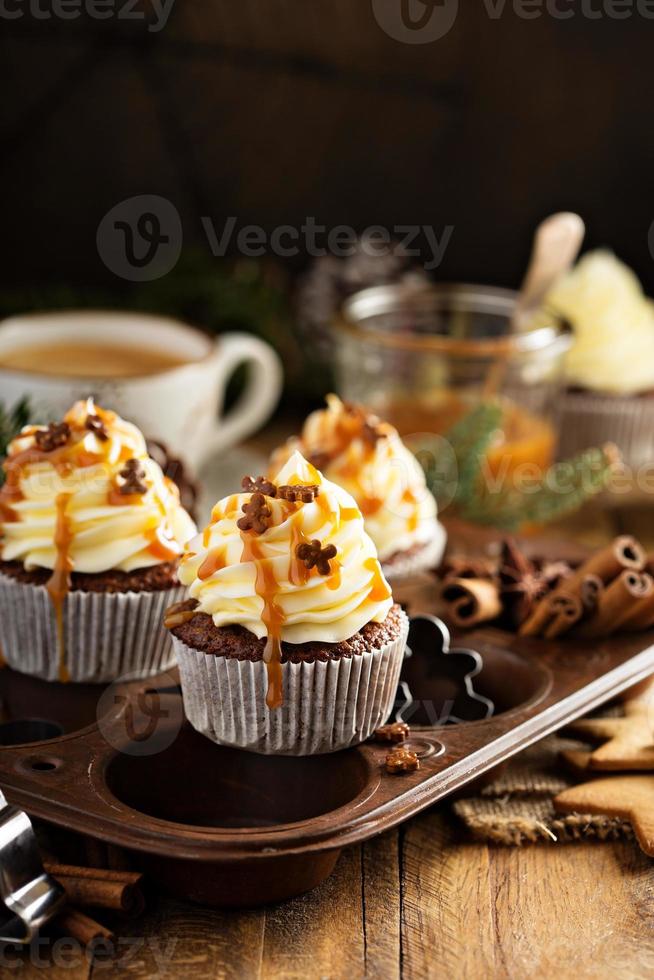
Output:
[452, 709, 633, 846]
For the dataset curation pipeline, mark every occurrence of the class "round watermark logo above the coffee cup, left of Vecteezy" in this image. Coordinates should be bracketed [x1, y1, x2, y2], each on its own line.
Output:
[96, 194, 183, 282]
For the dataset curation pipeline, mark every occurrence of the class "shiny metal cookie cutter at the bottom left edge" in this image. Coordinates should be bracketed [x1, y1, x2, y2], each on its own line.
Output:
[0, 792, 65, 943]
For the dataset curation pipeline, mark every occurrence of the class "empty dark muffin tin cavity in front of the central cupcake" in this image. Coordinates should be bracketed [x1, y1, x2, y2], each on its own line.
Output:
[106, 724, 369, 828]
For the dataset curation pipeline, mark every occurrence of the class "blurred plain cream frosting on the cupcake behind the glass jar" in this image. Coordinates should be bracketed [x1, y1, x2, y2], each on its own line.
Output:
[546, 250, 654, 395]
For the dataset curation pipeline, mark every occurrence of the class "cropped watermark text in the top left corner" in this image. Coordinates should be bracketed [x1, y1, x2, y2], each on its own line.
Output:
[0, 0, 175, 34]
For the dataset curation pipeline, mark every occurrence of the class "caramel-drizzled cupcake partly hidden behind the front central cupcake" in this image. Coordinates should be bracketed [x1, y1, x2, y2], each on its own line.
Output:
[271, 395, 445, 580]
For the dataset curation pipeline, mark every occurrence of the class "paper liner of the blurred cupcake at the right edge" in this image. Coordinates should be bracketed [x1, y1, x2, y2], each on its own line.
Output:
[559, 391, 654, 470]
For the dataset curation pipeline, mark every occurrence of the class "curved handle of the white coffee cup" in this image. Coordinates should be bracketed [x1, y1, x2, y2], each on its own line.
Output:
[200, 333, 283, 464]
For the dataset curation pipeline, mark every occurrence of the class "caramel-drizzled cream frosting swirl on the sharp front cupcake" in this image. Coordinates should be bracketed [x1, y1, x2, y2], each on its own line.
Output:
[179, 453, 392, 662]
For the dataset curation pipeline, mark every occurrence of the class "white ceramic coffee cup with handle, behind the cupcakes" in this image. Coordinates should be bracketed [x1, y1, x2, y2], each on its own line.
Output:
[0, 310, 282, 470]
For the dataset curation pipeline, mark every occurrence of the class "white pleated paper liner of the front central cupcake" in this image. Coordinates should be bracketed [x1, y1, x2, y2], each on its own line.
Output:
[174, 613, 409, 755]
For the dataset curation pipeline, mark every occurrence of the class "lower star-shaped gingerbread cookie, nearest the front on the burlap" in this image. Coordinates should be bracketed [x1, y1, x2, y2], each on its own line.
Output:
[554, 776, 654, 857]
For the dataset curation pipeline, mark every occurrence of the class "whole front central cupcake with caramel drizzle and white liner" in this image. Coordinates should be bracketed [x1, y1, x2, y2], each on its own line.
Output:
[166, 452, 408, 755]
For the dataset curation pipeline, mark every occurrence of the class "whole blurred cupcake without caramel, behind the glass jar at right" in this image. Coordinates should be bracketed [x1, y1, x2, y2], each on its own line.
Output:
[547, 250, 654, 469]
